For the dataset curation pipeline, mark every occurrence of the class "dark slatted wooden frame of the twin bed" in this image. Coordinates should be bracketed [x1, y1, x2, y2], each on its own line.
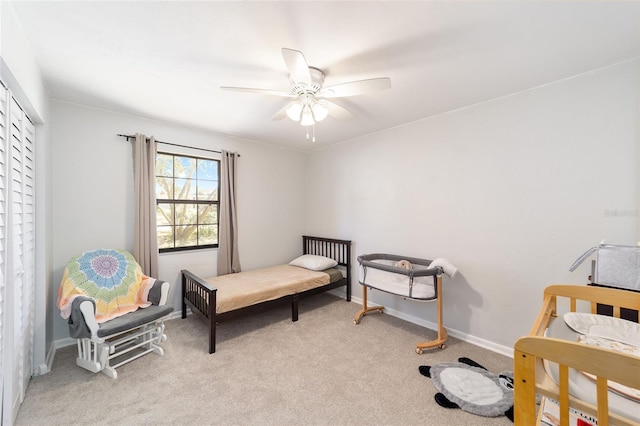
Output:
[182, 235, 351, 354]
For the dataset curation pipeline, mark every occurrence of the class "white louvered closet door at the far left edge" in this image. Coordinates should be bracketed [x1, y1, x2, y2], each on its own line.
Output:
[0, 85, 35, 424]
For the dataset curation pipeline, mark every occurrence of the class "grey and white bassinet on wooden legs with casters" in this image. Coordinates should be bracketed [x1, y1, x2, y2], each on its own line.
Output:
[353, 253, 458, 354]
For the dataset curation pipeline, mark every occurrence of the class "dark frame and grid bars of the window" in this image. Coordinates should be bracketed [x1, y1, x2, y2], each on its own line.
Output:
[154, 150, 220, 254]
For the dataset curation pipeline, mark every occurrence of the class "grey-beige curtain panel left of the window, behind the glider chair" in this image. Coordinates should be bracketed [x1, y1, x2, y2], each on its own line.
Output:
[133, 133, 158, 278]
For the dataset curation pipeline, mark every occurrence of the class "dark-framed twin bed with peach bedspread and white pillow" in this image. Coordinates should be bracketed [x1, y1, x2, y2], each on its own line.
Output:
[182, 236, 351, 353]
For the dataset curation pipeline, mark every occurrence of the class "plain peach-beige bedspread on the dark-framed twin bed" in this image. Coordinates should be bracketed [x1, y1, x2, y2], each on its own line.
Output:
[205, 265, 330, 314]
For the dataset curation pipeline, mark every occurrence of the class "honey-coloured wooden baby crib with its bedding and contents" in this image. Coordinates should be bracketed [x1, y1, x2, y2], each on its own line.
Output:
[514, 285, 640, 426]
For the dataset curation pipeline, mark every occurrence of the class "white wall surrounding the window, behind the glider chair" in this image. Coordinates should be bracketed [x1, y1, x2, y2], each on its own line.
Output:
[50, 101, 306, 339]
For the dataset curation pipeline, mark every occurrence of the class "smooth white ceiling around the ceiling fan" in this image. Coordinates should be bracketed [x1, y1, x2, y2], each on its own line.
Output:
[11, 0, 640, 150]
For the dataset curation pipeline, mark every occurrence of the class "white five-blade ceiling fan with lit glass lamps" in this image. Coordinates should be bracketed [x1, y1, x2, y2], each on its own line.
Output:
[221, 48, 391, 137]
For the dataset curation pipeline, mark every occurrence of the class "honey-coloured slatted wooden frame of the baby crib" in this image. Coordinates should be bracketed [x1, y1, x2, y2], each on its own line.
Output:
[514, 285, 640, 426]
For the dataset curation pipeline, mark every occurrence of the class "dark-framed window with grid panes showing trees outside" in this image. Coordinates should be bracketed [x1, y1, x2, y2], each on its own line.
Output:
[156, 152, 220, 253]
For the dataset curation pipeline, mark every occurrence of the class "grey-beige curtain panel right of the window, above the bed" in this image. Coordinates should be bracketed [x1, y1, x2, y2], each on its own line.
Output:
[218, 150, 240, 275]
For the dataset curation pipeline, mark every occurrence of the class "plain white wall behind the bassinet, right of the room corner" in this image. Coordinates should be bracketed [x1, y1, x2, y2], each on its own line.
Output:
[307, 60, 640, 353]
